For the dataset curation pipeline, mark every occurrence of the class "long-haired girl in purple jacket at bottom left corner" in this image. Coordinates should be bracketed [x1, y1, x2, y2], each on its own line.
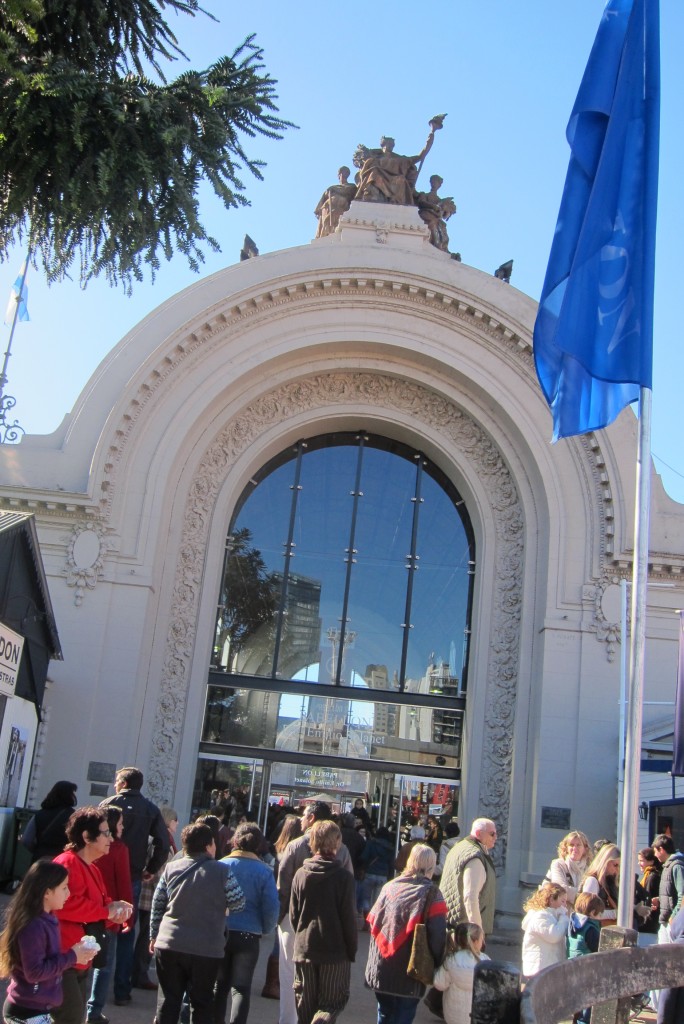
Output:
[0, 860, 97, 1024]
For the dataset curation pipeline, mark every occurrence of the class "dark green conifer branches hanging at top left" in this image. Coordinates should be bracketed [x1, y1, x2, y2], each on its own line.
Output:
[0, 0, 293, 290]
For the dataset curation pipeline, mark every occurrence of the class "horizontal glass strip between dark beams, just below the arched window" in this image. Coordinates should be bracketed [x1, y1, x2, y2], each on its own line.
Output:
[202, 686, 463, 768]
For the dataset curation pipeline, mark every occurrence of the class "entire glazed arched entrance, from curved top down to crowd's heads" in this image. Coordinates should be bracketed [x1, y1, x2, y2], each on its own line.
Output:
[189, 430, 475, 816]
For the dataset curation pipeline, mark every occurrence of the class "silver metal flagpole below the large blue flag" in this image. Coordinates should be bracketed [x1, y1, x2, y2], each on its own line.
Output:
[617, 387, 652, 928]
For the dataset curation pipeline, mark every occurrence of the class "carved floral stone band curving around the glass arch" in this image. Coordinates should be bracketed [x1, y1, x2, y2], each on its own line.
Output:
[146, 373, 524, 864]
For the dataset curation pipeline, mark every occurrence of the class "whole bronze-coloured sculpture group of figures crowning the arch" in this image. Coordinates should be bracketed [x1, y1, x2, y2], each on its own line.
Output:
[314, 114, 458, 258]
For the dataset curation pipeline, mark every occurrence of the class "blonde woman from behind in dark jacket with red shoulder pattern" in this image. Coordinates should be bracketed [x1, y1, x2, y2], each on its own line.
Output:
[366, 843, 446, 1024]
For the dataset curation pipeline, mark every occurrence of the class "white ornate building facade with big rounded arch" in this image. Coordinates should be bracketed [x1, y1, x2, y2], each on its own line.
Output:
[0, 204, 684, 912]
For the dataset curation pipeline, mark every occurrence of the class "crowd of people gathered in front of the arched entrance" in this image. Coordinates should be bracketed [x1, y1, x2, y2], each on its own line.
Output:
[0, 768, 684, 1024]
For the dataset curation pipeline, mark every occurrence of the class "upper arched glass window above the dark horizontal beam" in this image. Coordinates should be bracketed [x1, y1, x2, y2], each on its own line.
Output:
[212, 432, 475, 694]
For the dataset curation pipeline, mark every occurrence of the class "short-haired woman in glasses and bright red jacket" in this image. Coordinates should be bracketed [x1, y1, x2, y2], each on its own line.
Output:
[52, 807, 133, 1024]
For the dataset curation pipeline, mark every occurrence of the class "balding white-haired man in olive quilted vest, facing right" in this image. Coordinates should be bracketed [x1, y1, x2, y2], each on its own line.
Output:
[439, 818, 497, 935]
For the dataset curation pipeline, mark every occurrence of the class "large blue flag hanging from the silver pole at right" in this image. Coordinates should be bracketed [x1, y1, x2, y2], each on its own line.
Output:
[535, 0, 660, 440]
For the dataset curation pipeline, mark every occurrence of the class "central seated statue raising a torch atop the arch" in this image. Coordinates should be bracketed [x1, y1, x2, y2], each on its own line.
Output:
[354, 127, 434, 206]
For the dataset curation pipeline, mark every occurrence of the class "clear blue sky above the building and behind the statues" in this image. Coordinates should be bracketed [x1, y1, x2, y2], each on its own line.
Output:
[0, 0, 684, 502]
